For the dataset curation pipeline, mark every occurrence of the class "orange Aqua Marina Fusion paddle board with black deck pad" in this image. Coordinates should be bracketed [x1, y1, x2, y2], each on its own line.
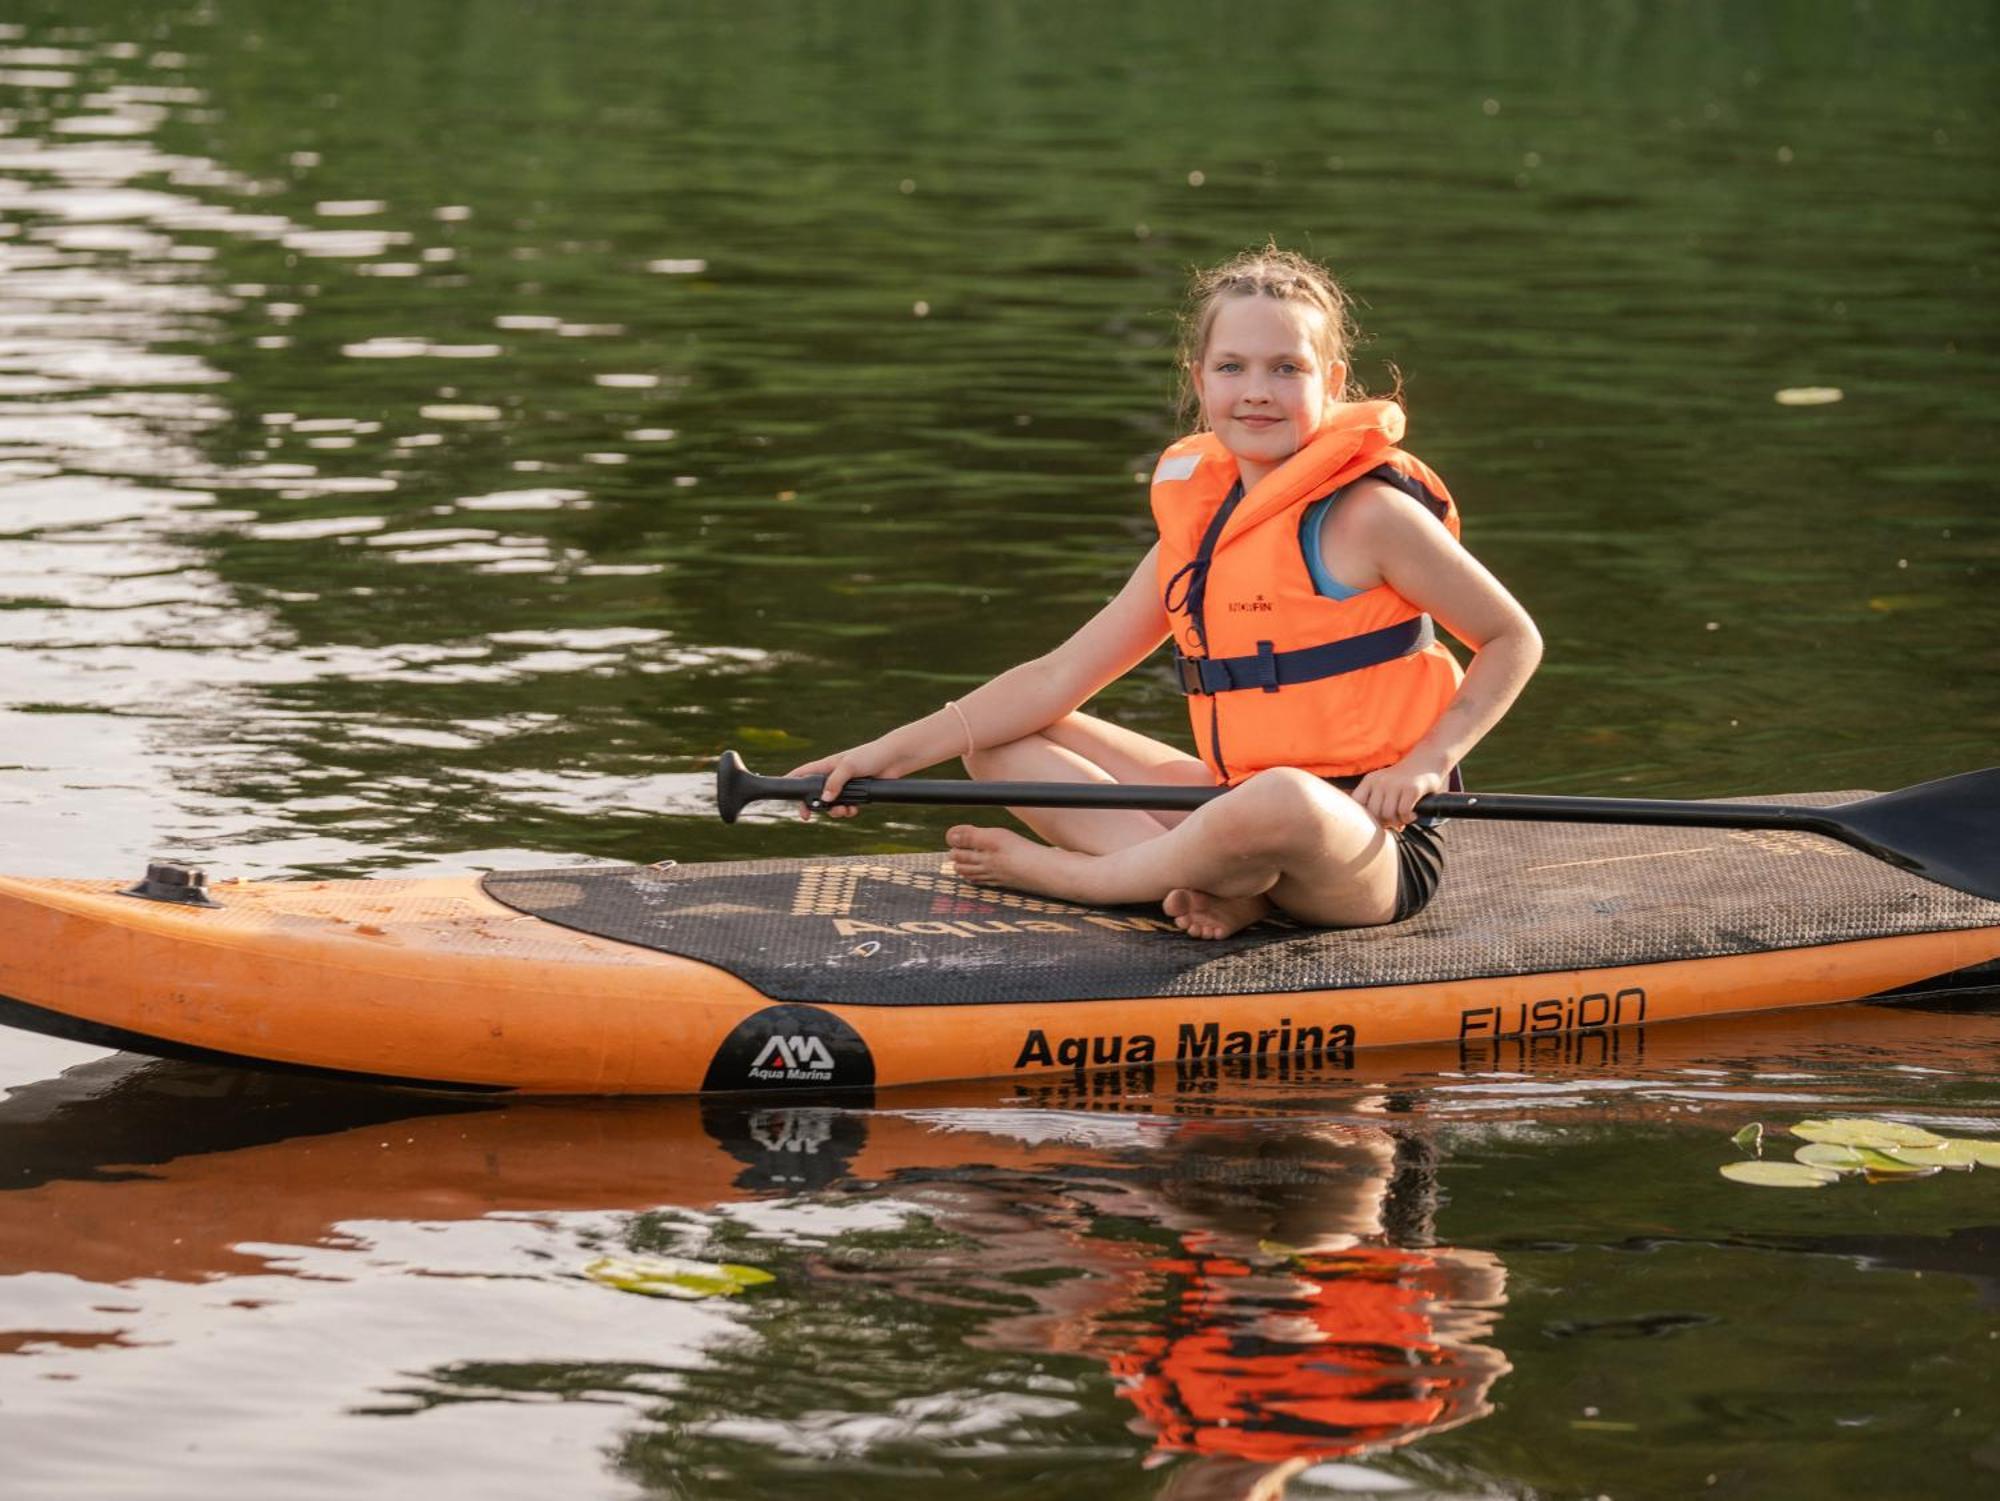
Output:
[0, 793, 2000, 1095]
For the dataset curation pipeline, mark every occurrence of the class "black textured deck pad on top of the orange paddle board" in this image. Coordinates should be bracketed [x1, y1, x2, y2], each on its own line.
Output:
[484, 793, 2000, 1007]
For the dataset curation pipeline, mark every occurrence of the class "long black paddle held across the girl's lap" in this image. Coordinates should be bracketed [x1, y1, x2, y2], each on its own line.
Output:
[716, 751, 2000, 901]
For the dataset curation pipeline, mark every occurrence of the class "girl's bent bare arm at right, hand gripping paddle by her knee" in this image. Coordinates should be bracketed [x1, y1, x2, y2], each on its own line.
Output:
[1322, 482, 1542, 829]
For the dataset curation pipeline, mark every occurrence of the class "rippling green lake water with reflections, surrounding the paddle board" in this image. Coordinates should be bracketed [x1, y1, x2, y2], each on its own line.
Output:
[0, 0, 2000, 1501]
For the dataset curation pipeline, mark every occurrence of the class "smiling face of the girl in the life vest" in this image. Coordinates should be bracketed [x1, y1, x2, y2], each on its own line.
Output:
[1194, 296, 1346, 486]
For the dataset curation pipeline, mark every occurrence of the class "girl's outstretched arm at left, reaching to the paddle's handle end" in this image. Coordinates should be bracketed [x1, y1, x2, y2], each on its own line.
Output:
[790, 544, 1168, 817]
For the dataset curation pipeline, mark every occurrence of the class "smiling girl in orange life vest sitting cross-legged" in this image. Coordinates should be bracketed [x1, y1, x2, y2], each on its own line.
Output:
[792, 246, 1542, 939]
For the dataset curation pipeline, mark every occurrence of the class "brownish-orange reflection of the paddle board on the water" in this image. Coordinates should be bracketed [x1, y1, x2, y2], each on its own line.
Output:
[0, 1007, 2000, 1283]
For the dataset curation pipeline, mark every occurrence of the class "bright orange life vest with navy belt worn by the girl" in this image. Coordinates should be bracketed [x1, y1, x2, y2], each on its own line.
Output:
[1152, 402, 1460, 783]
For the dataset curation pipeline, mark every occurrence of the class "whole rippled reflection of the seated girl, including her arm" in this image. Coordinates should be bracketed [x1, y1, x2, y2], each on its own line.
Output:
[898, 1119, 1508, 1501]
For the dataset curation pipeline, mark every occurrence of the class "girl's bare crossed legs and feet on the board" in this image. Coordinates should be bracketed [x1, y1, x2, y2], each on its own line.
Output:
[948, 712, 1396, 939]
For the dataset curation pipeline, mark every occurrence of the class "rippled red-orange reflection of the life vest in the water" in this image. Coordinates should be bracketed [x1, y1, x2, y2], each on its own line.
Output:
[1110, 1235, 1506, 1463]
